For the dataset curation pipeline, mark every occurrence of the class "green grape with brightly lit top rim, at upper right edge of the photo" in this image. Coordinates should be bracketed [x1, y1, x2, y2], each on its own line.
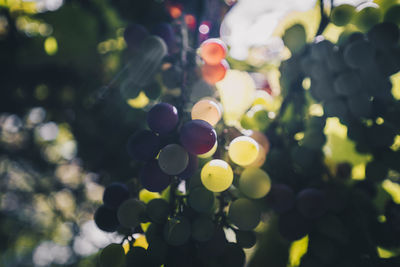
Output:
[353, 3, 382, 32]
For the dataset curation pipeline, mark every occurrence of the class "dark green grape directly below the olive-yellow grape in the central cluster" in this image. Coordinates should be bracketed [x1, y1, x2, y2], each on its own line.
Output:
[228, 198, 261, 230]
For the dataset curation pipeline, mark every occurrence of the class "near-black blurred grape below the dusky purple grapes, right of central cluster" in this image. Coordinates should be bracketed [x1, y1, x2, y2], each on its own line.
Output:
[278, 209, 311, 241]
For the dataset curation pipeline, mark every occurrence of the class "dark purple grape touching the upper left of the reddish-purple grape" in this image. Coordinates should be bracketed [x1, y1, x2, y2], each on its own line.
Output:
[147, 103, 179, 135]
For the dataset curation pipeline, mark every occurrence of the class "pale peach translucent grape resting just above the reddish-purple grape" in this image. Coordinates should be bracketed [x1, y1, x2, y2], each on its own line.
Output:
[191, 99, 222, 126]
